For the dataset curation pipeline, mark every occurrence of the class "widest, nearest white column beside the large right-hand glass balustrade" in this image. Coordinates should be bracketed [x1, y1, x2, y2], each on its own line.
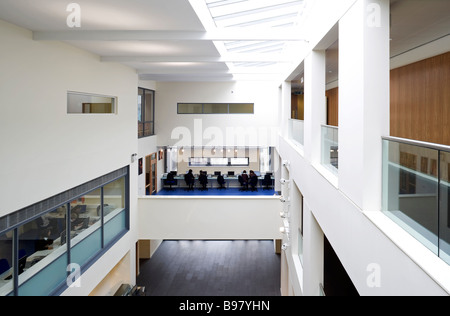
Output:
[339, 0, 390, 211]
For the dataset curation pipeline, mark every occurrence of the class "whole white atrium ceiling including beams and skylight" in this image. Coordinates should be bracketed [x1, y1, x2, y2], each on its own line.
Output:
[0, 0, 310, 81]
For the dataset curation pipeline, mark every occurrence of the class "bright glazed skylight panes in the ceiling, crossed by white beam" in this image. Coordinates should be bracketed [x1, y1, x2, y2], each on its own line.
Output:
[195, 0, 308, 78]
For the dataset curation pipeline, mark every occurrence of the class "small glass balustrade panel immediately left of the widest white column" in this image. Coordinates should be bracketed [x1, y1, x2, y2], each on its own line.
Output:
[322, 125, 339, 174]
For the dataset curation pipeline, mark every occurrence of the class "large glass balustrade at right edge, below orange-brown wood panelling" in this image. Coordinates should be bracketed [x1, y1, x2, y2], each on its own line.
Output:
[383, 139, 450, 264]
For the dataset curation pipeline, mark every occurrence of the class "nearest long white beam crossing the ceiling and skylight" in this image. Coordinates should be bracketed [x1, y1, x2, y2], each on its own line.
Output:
[33, 29, 305, 41]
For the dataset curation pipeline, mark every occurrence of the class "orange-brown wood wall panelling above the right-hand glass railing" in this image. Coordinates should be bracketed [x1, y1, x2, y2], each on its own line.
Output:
[390, 52, 450, 145]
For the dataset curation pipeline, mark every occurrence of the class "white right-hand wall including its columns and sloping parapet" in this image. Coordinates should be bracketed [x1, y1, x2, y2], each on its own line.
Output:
[277, 0, 450, 295]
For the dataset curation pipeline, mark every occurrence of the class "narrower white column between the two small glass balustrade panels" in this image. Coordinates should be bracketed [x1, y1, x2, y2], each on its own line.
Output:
[304, 51, 326, 164]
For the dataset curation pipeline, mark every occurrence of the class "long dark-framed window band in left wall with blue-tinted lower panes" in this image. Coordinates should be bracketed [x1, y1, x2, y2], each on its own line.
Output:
[0, 169, 129, 296]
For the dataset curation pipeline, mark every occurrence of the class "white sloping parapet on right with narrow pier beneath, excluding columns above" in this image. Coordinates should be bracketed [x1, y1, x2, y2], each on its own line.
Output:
[280, 139, 446, 295]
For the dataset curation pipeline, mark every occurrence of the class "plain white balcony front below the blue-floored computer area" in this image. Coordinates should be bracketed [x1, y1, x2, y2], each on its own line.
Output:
[139, 196, 281, 240]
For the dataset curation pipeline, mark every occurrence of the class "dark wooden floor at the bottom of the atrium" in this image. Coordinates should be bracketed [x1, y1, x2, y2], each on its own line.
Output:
[137, 241, 280, 296]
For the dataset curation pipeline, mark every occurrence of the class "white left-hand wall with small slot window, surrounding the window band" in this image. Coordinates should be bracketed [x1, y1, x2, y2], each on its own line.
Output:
[0, 21, 138, 295]
